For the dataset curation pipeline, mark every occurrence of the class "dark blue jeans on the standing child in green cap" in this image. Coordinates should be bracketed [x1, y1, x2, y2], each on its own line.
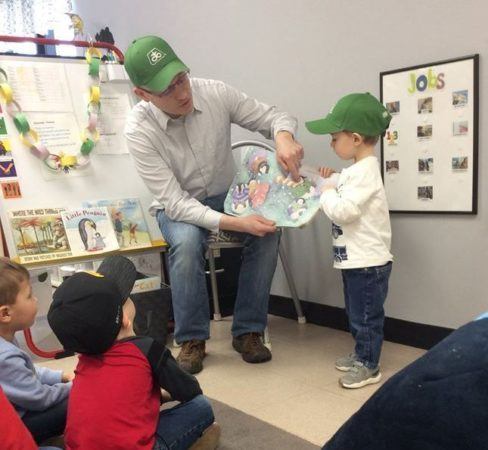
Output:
[342, 261, 392, 369]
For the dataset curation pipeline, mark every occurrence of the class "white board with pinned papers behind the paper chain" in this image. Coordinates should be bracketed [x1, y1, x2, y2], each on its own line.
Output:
[0, 54, 163, 266]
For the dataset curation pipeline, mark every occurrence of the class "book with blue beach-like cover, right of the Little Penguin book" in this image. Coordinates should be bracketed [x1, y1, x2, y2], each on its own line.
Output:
[83, 198, 151, 249]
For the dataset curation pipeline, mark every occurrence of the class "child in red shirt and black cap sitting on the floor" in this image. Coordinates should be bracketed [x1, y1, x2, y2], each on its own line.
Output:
[48, 256, 220, 450]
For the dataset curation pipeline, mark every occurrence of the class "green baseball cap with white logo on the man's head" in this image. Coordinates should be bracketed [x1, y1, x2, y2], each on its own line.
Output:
[124, 36, 189, 92]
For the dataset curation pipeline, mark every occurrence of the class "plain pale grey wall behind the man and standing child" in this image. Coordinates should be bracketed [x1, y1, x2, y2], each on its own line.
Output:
[76, 0, 488, 327]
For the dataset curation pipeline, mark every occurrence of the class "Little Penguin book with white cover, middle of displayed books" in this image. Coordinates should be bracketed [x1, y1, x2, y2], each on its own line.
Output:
[61, 208, 119, 256]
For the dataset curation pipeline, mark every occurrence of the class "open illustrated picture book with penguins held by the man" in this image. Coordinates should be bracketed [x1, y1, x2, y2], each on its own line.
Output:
[224, 146, 321, 227]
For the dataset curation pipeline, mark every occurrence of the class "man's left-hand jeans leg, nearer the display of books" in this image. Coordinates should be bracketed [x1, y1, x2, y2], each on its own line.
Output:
[157, 211, 210, 343]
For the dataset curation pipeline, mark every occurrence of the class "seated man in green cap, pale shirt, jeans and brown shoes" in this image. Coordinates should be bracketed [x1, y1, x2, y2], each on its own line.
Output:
[124, 36, 303, 373]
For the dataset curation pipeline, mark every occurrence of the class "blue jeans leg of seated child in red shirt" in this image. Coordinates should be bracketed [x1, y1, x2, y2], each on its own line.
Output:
[154, 395, 215, 450]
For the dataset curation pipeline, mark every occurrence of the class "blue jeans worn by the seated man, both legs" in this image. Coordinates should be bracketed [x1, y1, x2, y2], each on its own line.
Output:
[157, 194, 280, 343]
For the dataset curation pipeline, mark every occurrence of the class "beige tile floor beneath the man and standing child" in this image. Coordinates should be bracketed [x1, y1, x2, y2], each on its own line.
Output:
[39, 316, 424, 445]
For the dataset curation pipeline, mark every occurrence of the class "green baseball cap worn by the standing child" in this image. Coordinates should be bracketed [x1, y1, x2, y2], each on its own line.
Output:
[305, 92, 391, 136]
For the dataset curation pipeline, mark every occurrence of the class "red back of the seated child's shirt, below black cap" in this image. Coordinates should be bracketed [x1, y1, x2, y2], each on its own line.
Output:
[65, 341, 160, 450]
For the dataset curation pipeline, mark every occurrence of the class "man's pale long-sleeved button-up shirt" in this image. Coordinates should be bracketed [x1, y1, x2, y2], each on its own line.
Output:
[125, 78, 297, 230]
